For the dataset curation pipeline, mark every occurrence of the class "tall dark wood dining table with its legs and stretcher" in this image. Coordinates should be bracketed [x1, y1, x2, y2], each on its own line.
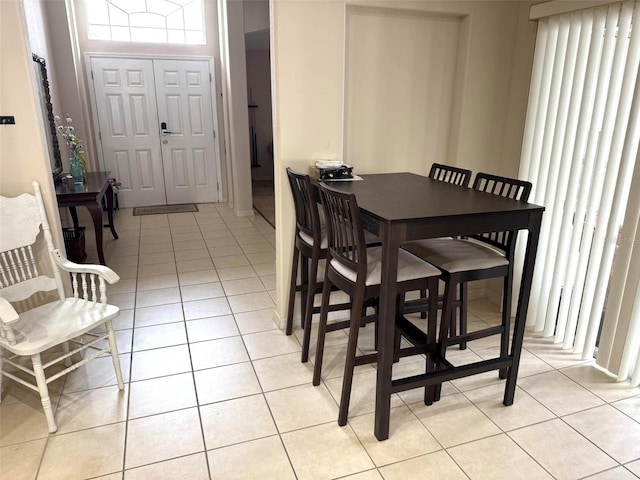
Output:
[330, 173, 544, 440]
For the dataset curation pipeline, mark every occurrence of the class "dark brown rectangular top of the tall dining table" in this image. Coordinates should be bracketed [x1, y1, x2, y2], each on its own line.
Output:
[327, 173, 544, 223]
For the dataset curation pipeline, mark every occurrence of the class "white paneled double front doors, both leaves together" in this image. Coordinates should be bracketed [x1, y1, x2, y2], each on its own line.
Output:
[90, 56, 220, 207]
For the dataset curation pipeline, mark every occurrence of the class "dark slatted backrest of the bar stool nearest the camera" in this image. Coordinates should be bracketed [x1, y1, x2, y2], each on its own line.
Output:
[320, 183, 367, 281]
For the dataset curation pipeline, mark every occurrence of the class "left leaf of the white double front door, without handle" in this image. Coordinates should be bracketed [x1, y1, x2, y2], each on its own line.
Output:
[91, 57, 166, 207]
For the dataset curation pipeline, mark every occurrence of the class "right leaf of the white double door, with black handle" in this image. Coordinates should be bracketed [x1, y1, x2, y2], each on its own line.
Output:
[154, 60, 218, 204]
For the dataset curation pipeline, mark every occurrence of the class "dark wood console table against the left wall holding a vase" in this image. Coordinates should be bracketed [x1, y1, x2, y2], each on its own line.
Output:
[56, 172, 118, 265]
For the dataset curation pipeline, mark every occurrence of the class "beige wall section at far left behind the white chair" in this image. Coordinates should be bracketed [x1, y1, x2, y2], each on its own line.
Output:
[0, 0, 64, 270]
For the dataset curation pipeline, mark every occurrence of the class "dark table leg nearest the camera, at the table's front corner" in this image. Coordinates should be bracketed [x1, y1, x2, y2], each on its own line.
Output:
[374, 224, 400, 440]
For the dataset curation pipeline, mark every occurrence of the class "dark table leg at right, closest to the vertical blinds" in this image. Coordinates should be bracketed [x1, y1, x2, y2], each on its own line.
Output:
[502, 212, 542, 406]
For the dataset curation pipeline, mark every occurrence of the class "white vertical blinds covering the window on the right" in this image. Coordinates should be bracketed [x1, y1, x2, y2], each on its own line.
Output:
[519, 1, 640, 378]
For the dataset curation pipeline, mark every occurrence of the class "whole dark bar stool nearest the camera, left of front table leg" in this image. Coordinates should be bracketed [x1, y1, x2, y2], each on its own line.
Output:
[313, 183, 440, 425]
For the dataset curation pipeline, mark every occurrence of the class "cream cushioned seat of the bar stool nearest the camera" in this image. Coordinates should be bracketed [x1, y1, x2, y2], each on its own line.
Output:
[331, 247, 440, 286]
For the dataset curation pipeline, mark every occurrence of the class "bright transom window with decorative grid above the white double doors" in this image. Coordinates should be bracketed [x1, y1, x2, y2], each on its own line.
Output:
[84, 0, 206, 45]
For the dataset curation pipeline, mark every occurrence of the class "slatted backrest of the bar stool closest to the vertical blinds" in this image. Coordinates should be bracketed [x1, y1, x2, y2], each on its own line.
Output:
[471, 172, 532, 255]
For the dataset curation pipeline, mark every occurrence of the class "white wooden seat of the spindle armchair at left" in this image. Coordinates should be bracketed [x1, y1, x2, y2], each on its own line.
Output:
[0, 298, 120, 355]
